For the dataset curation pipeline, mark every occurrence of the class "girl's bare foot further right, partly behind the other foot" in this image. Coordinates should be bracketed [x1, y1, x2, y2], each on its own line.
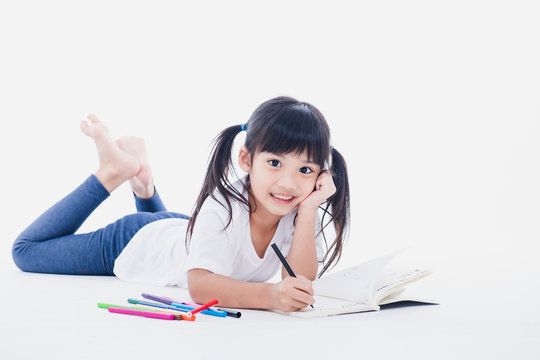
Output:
[115, 136, 154, 199]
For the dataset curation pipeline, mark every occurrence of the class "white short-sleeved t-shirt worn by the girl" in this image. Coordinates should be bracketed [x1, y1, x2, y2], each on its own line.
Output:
[113, 177, 325, 287]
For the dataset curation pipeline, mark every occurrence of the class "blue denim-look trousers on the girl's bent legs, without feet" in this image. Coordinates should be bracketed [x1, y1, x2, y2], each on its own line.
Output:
[12, 175, 188, 275]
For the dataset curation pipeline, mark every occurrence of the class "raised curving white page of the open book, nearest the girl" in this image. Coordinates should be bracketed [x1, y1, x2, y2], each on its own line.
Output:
[313, 250, 403, 304]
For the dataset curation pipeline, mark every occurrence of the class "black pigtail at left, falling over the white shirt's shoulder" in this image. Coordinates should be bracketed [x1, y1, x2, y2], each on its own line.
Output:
[186, 125, 249, 250]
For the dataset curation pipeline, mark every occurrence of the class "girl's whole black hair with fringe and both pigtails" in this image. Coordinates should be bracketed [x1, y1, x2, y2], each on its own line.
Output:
[186, 96, 350, 277]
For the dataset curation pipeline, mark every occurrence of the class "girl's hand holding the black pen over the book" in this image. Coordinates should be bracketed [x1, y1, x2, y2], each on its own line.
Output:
[270, 275, 315, 312]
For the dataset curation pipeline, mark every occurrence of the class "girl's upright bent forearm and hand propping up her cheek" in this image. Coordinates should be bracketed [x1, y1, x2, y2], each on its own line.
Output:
[281, 170, 336, 280]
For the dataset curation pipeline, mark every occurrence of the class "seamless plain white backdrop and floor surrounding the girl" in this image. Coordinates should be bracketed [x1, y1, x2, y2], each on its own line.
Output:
[0, 0, 540, 360]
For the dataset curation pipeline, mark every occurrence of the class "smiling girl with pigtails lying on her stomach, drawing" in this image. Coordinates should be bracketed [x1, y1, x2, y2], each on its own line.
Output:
[13, 97, 349, 311]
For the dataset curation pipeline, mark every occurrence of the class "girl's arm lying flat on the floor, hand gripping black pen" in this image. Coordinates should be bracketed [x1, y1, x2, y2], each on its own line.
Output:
[188, 269, 315, 312]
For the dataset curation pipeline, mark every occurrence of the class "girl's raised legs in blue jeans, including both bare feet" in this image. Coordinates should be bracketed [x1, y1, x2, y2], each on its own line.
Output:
[12, 115, 187, 275]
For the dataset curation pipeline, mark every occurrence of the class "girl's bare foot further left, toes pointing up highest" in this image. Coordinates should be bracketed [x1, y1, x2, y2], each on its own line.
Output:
[81, 115, 141, 193]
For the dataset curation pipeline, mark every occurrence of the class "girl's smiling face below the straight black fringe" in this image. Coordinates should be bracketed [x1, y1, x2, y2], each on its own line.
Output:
[239, 147, 321, 216]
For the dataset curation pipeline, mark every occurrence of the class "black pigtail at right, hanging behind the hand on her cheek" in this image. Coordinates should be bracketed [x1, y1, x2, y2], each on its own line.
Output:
[319, 148, 350, 277]
